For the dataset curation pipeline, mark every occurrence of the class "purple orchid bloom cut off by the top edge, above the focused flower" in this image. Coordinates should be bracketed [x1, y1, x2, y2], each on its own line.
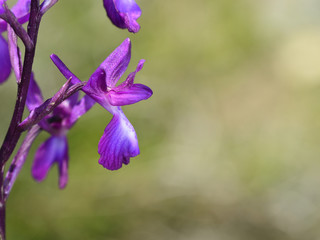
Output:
[103, 0, 141, 33]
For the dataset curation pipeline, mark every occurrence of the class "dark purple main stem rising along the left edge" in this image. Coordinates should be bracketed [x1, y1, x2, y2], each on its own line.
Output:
[0, 0, 41, 240]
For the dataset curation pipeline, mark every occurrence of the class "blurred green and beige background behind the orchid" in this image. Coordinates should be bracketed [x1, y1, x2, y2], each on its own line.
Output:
[0, 0, 320, 240]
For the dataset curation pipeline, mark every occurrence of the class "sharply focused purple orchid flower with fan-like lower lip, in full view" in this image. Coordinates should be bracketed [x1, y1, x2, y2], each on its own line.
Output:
[51, 39, 152, 170]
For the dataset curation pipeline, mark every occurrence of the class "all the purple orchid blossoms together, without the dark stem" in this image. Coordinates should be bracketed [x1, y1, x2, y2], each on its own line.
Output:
[0, 0, 153, 188]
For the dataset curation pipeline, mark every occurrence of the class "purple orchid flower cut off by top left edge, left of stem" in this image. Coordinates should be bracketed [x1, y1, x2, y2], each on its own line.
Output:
[0, 0, 31, 84]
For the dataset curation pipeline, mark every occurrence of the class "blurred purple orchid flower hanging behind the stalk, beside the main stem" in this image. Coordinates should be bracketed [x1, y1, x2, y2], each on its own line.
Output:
[26, 75, 90, 189]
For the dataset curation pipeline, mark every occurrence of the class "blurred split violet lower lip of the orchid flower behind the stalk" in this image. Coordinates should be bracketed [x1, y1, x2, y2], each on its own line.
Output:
[32, 136, 68, 188]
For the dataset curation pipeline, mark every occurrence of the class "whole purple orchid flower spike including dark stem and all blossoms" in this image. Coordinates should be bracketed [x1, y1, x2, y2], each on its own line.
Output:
[0, 0, 152, 239]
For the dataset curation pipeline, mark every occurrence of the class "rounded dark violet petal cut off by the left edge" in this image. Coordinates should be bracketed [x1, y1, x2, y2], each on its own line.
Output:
[0, 35, 11, 84]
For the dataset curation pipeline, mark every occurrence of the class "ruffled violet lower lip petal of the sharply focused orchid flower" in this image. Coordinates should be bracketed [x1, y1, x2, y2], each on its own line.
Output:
[98, 112, 140, 170]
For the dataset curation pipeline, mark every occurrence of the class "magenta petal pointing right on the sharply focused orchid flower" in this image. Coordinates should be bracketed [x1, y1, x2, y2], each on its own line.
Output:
[108, 84, 152, 106]
